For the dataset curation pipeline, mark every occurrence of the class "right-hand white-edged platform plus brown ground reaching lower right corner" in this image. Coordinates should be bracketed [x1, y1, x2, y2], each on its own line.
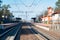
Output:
[34, 23, 60, 40]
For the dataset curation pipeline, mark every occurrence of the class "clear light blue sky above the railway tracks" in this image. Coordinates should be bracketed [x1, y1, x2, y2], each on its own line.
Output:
[2, 0, 57, 20]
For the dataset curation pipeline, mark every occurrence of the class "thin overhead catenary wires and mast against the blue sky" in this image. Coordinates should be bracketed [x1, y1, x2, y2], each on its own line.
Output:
[8, 0, 41, 19]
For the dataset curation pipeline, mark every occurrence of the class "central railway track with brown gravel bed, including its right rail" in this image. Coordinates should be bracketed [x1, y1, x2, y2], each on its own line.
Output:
[20, 25, 49, 40]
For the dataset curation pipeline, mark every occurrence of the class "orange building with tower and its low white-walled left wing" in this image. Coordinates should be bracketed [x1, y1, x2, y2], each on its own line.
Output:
[42, 7, 54, 24]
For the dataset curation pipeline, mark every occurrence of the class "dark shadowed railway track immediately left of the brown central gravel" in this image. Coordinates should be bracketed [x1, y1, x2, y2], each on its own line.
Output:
[0, 24, 21, 40]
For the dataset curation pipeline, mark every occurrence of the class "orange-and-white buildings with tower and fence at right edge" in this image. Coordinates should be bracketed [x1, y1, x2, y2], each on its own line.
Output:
[42, 7, 60, 32]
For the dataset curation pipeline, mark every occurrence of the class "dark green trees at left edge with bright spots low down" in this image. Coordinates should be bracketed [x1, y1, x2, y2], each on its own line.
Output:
[0, 5, 13, 22]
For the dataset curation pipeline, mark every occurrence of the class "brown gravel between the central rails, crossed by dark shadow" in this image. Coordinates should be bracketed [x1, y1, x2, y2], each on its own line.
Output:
[20, 26, 39, 40]
